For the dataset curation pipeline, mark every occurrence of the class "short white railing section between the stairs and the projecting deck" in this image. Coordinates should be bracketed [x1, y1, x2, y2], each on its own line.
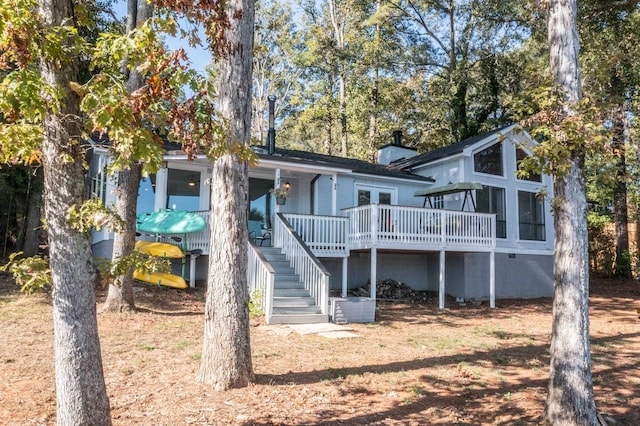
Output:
[284, 213, 349, 257]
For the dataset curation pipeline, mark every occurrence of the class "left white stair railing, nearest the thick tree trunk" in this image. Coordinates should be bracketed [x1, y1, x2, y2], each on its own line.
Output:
[247, 240, 276, 324]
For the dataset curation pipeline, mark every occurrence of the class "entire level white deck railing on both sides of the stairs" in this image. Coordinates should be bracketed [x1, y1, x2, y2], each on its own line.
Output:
[185, 204, 496, 257]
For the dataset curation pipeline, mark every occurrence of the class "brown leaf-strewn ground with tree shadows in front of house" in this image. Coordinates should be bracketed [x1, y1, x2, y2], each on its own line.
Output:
[0, 276, 640, 425]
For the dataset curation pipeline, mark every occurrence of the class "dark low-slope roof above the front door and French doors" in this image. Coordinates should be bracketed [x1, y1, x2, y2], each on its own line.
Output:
[253, 146, 434, 182]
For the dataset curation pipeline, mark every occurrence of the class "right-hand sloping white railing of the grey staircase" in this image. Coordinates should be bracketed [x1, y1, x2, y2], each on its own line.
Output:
[272, 213, 331, 315]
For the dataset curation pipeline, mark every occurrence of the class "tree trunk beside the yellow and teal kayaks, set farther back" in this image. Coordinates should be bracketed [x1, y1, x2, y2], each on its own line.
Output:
[102, 0, 152, 312]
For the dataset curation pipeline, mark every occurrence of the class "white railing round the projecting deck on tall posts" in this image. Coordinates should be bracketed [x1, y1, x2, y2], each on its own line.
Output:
[345, 204, 496, 250]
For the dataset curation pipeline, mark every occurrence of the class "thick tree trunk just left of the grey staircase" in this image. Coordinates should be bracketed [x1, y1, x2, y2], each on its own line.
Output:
[197, 0, 254, 390]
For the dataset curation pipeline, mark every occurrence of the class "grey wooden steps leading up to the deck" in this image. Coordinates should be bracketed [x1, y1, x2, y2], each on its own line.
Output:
[259, 247, 329, 324]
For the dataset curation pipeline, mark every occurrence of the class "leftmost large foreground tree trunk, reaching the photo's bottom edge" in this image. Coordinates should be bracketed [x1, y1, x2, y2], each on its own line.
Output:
[40, 0, 111, 425]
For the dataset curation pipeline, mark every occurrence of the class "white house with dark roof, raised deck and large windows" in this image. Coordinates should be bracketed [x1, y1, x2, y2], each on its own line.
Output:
[91, 125, 553, 322]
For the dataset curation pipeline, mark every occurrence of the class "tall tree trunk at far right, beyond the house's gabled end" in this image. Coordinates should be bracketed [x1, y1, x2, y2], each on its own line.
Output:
[545, 0, 597, 425]
